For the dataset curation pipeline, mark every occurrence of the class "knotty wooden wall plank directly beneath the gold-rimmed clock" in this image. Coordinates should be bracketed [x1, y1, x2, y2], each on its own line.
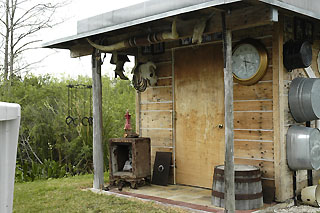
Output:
[233, 82, 272, 100]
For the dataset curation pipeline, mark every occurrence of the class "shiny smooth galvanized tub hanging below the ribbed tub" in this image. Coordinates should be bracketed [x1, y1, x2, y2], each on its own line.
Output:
[287, 126, 320, 170]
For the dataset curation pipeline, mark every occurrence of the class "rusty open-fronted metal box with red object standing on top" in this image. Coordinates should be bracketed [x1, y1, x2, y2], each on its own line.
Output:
[109, 138, 151, 188]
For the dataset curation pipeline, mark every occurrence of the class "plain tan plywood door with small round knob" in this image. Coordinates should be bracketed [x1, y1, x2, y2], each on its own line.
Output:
[174, 45, 224, 188]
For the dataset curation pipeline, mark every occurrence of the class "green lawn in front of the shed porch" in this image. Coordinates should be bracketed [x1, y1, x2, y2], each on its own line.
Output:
[13, 175, 181, 213]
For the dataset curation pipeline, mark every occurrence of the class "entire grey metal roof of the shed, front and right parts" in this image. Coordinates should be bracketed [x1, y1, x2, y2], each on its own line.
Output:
[43, 0, 320, 49]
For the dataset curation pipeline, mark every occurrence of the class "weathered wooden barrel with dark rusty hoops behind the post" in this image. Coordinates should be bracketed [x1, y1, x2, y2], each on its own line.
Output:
[212, 164, 263, 210]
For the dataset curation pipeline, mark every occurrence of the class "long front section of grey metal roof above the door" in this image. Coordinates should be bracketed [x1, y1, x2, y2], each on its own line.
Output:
[42, 0, 241, 49]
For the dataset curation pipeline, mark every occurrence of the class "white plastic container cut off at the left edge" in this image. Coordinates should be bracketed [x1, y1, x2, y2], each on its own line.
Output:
[0, 102, 21, 213]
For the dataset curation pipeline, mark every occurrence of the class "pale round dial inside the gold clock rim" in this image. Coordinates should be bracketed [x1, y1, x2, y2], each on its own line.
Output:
[232, 43, 260, 80]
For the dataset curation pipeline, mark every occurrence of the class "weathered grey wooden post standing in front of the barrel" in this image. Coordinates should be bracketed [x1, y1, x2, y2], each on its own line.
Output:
[222, 13, 235, 212]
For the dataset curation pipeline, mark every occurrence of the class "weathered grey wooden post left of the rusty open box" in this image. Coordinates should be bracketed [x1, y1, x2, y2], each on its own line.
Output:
[92, 50, 104, 189]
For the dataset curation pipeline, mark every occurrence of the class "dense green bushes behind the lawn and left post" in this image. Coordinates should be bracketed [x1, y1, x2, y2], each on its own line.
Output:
[0, 75, 135, 181]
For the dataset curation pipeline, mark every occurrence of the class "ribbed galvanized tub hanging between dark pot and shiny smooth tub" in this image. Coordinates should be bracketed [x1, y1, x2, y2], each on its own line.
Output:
[289, 78, 320, 123]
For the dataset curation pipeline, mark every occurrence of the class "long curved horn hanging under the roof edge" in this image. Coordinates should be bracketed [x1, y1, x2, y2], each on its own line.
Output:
[87, 20, 179, 52]
